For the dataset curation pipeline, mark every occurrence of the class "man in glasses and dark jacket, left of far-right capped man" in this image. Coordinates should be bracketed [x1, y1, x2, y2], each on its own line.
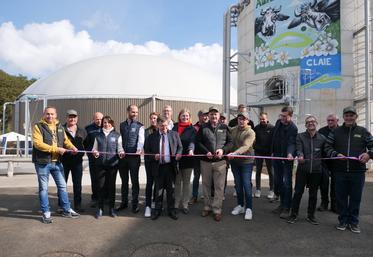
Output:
[288, 115, 325, 225]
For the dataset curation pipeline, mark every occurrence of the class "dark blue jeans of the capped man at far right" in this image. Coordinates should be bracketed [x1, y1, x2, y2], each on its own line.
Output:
[335, 171, 365, 225]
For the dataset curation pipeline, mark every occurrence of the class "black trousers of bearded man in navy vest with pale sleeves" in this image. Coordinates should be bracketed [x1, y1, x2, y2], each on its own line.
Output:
[119, 155, 141, 205]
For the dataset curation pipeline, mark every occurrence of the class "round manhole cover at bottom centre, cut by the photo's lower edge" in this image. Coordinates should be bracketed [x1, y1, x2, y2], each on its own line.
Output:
[131, 243, 189, 257]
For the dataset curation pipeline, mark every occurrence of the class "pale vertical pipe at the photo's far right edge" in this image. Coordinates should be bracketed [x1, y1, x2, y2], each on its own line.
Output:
[364, 0, 371, 131]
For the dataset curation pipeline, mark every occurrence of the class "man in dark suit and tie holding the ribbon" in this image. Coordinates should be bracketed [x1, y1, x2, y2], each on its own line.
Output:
[144, 117, 183, 220]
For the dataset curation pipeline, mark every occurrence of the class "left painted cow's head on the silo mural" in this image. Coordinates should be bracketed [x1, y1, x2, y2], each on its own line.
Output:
[255, 6, 289, 37]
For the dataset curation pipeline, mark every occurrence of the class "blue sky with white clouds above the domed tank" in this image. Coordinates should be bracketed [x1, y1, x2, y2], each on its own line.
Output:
[0, 0, 238, 78]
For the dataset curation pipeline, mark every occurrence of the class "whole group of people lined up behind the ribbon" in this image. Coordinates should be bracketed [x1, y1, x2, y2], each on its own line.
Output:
[33, 105, 373, 233]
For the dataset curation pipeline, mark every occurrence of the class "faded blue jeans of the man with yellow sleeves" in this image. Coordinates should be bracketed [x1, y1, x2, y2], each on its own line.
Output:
[35, 162, 70, 213]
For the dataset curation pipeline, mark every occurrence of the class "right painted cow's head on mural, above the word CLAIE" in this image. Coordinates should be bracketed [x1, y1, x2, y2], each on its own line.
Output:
[288, 0, 340, 31]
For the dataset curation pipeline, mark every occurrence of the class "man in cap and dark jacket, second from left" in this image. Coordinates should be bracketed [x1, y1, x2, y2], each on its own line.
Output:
[61, 110, 87, 212]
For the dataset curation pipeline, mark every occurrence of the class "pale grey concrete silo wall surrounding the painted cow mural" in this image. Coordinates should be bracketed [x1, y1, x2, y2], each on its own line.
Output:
[237, 0, 356, 130]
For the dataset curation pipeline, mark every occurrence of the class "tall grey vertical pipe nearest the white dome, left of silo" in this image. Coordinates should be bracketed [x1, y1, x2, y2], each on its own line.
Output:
[222, 7, 231, 117]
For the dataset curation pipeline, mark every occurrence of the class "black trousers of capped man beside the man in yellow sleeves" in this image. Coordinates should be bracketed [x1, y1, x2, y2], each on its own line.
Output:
[63, 162, 83, 208]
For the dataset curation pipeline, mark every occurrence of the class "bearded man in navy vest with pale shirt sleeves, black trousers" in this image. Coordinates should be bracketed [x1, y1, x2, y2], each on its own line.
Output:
[117, 105, 145, 213]
